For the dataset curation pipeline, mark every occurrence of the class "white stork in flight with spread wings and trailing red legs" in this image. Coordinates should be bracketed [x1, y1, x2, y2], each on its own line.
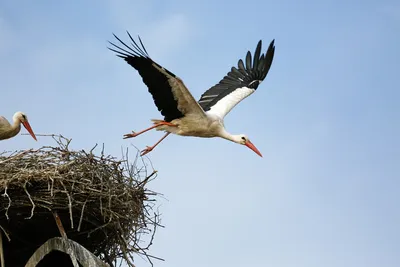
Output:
[109, 32, 275, 157]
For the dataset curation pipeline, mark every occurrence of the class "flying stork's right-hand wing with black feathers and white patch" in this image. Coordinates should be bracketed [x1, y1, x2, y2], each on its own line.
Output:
[199, 40, 275, 118]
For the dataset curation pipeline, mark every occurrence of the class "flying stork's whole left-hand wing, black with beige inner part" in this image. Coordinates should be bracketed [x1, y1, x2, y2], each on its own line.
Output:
[109, 32, 204, 122]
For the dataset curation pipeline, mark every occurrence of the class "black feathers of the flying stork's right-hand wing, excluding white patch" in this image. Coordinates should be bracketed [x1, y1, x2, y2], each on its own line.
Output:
[199, 40, 275, 111]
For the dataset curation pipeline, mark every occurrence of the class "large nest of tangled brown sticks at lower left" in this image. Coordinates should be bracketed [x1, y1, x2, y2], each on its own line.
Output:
[0, 135, 160, 266]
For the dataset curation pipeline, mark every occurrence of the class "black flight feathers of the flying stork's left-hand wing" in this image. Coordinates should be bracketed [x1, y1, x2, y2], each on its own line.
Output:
[108, 32, 184, 122]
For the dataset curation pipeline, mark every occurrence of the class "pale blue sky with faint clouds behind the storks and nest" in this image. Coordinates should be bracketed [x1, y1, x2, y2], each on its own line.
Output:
[0, 0, 400, 267]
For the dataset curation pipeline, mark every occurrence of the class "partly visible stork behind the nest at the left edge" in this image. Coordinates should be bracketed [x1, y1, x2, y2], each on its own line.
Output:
[0, 111, 37, 141]
